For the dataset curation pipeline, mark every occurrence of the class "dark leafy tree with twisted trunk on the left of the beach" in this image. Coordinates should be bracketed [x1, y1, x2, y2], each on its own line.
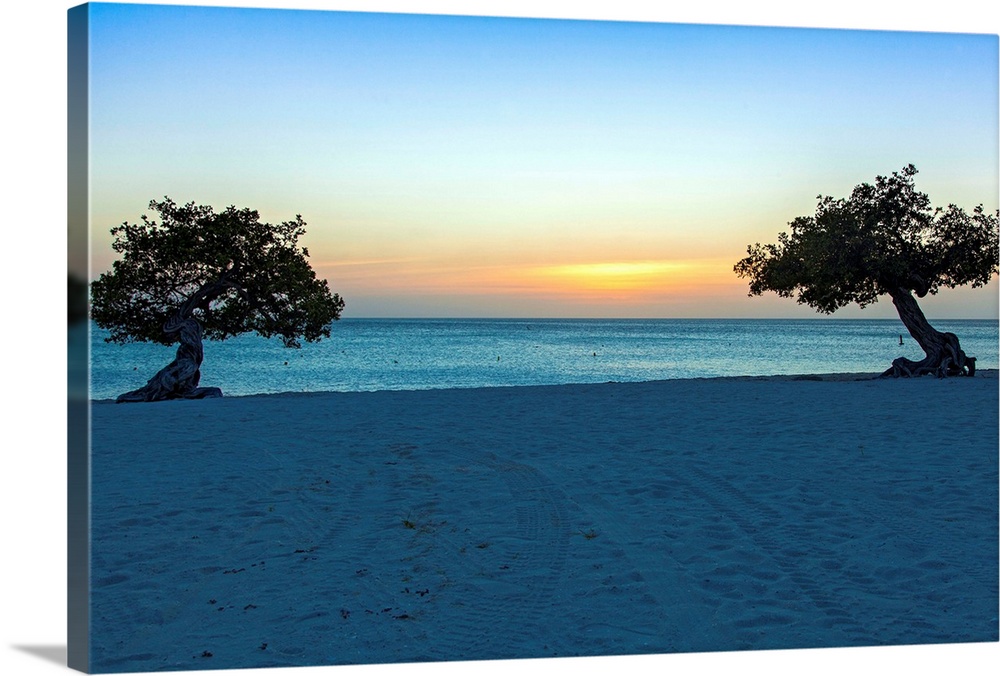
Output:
[90, 198, 344, 402]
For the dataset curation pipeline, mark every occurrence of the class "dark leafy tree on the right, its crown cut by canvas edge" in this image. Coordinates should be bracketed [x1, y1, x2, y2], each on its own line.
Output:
[734, 164, 1000, 377]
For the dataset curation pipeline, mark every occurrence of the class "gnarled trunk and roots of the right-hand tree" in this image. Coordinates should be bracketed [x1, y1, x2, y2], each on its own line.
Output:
[882, 288, 976, 378]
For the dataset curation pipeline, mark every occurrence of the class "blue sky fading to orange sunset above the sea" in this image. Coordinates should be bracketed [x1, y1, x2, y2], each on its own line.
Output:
[80, 3, 998, 318]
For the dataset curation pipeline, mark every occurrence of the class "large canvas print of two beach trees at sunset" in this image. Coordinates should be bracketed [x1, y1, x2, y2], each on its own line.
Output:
[68, 3, 998, 673]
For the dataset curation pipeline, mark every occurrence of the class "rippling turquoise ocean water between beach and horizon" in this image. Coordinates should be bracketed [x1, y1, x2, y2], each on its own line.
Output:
[80, 318, 998, 399]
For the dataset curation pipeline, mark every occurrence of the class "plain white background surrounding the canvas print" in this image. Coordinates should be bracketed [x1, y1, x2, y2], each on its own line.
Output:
[0, 0, 1000, 676]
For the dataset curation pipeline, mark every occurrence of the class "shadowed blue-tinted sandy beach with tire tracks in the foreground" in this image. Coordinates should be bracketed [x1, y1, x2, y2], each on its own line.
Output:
[92, 371, 998, 671]
